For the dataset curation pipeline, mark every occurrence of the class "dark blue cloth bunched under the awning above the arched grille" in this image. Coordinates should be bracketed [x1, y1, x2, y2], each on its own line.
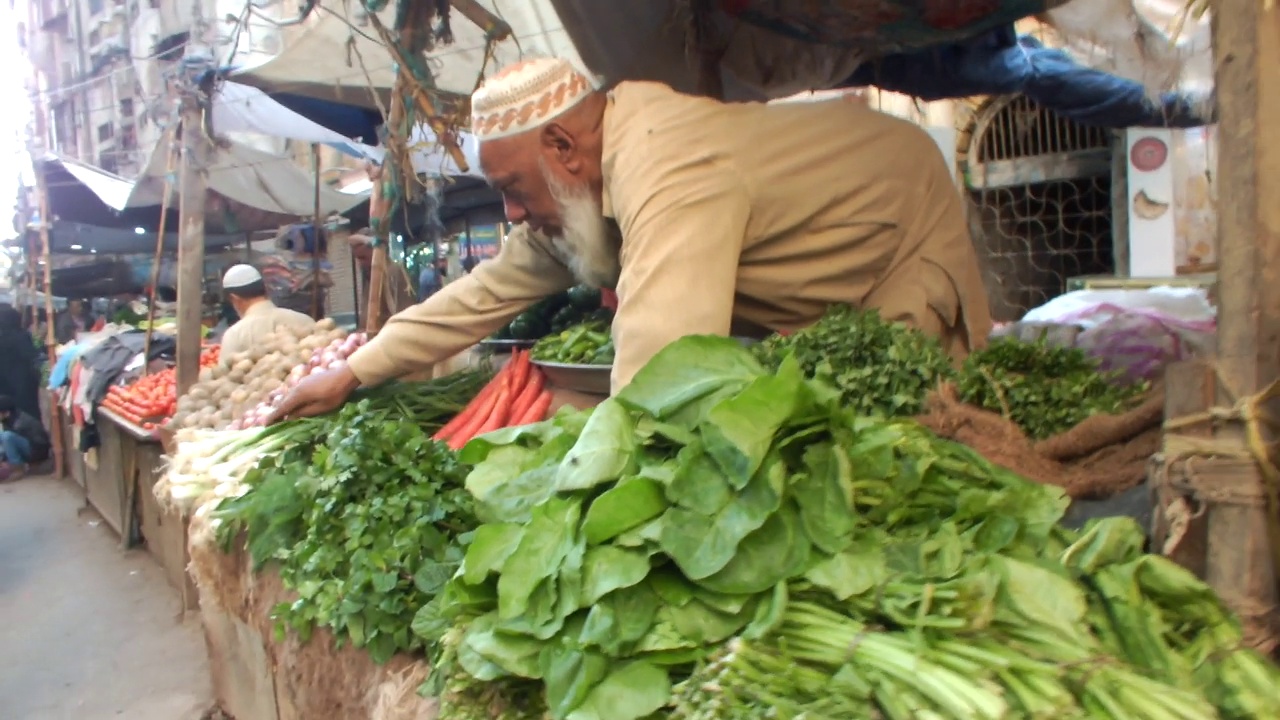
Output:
[845, 27, 1215, 128]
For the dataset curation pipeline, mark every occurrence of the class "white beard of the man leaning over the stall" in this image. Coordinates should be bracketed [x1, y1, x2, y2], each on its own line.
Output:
[543, 167, 622, 288]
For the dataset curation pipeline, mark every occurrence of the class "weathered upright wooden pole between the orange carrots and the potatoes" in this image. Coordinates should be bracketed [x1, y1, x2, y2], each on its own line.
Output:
[178, 87, 210, 397]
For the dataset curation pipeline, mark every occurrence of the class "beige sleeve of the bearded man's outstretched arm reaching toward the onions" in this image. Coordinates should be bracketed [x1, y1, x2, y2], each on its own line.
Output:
[349, 225, 573, 386]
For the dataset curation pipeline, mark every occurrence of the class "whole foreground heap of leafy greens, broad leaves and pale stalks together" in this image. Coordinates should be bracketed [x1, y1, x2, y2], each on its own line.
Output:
[413, 338, 1280, 720]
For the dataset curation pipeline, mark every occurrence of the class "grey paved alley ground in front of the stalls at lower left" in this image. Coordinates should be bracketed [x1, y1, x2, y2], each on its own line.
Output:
[0, 478, 212, 720]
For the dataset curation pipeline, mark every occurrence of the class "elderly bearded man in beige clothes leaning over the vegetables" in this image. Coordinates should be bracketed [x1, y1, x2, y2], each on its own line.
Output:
[267, 59, 991, 416]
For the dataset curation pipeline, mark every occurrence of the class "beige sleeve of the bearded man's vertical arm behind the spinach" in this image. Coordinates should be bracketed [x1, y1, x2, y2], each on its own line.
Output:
[609, 155, 750, 392]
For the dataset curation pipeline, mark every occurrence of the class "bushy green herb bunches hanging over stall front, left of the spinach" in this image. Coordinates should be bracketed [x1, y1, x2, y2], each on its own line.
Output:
[214, 373, 486, 662]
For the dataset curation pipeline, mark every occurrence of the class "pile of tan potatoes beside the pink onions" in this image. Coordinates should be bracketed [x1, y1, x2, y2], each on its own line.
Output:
[169, 319, 347, 430]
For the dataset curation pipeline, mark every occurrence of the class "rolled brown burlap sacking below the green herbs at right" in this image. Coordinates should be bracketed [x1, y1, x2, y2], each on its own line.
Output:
[916, 384, 1165, 500]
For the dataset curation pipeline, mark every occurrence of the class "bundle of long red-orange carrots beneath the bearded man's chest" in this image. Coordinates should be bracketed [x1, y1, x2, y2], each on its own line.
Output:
[434, 350, 552, 450]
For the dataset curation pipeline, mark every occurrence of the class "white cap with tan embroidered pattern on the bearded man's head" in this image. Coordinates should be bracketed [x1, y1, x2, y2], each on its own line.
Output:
[471, 58, 594, 142]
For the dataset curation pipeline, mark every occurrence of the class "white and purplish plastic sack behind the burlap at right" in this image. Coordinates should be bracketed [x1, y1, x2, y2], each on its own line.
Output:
[1023, 287, 1217, 379]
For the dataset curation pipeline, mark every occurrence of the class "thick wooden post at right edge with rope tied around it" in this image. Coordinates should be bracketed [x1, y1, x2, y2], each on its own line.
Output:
[1206, 0, 1280, 638]
